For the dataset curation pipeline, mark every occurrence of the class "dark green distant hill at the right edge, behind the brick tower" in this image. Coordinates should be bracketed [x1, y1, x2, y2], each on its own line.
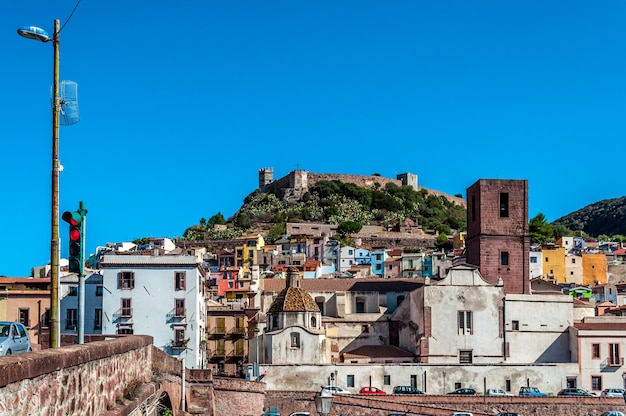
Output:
[552, 196, 626, 237]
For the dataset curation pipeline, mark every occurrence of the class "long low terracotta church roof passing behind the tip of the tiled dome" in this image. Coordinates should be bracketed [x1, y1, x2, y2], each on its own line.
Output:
[262, 277, 424, 293]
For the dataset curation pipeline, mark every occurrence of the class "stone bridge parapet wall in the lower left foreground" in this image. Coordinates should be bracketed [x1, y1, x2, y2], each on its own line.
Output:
[0, 336, 154, 415]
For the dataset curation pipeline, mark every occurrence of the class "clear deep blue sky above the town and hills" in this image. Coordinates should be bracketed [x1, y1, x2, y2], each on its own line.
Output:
[0, 0, 626, 276]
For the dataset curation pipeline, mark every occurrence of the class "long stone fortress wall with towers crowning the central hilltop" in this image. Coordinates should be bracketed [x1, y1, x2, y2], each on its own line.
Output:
[259, 168, 466, 208]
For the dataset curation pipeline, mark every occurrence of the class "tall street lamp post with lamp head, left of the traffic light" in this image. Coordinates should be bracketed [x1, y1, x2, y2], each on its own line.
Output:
[17, 19, 61, 348]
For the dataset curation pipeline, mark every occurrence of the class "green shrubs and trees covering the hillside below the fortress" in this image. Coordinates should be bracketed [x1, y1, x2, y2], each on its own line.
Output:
[183, 180, 467, 240]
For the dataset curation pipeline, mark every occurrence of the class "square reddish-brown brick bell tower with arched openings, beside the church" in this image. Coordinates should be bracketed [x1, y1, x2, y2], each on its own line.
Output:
[465, 179, 530, 293]
